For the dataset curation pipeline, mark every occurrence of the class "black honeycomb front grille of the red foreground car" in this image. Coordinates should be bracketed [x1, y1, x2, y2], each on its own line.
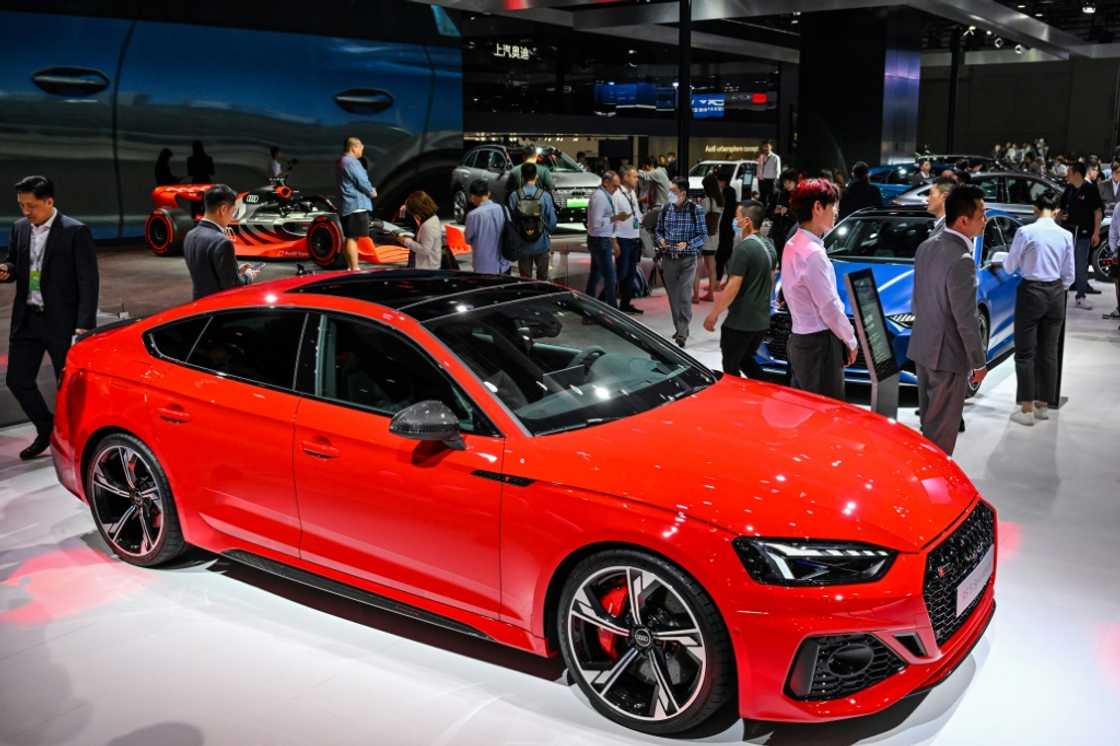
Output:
[922, 502, 996, 645]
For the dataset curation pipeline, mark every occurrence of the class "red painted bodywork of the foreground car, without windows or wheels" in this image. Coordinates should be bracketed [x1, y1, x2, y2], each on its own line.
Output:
[52, 274, 995, 721]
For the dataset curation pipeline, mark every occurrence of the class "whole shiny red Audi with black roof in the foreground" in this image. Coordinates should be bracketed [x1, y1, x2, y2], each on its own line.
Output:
[52, 270, 996, 734]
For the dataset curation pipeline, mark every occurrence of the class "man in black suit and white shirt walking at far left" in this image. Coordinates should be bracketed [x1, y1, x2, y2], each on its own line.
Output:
[0, 176, 99, 459]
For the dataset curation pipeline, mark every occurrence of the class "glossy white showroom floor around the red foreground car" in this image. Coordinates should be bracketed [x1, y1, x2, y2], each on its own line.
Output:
[0, 257, 1120, 746]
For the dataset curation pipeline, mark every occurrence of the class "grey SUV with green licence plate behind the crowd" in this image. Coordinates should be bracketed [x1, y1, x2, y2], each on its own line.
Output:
[451, 144, 601, 223]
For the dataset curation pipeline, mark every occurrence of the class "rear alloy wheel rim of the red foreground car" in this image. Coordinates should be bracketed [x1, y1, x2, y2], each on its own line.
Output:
[88, 444, 165, 557]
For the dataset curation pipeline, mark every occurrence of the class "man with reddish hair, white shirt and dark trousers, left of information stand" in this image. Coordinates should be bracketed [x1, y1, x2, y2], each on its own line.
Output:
[782, 179, 857, 401]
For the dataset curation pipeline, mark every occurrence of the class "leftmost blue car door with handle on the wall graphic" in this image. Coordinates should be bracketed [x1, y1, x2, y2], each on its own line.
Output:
[0, 11, 133, 245]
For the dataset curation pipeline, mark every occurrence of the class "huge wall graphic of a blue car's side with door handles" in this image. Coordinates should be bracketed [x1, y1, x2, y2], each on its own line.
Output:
[0, 0, 463, 242]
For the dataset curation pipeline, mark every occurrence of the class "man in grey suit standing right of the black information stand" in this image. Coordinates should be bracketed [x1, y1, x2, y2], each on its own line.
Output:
[907, 184, 988, 456]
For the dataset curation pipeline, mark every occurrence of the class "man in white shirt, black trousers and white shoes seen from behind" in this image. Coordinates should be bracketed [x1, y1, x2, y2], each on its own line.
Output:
[1004, 193, 1074, 426]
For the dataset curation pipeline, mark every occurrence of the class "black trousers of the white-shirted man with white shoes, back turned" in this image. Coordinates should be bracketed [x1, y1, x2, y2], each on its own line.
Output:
[1015, 280, 1065, 403]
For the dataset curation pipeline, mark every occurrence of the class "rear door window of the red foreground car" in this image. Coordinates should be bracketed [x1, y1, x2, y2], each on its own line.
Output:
[187, 309, 307, 389]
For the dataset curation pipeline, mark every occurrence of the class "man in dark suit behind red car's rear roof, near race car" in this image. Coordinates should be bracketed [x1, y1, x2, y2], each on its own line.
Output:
[183, 184, 256, 300]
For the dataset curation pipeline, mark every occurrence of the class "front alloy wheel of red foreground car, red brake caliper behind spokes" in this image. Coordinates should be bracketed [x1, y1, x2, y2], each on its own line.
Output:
[568, 566, 708, 722]
